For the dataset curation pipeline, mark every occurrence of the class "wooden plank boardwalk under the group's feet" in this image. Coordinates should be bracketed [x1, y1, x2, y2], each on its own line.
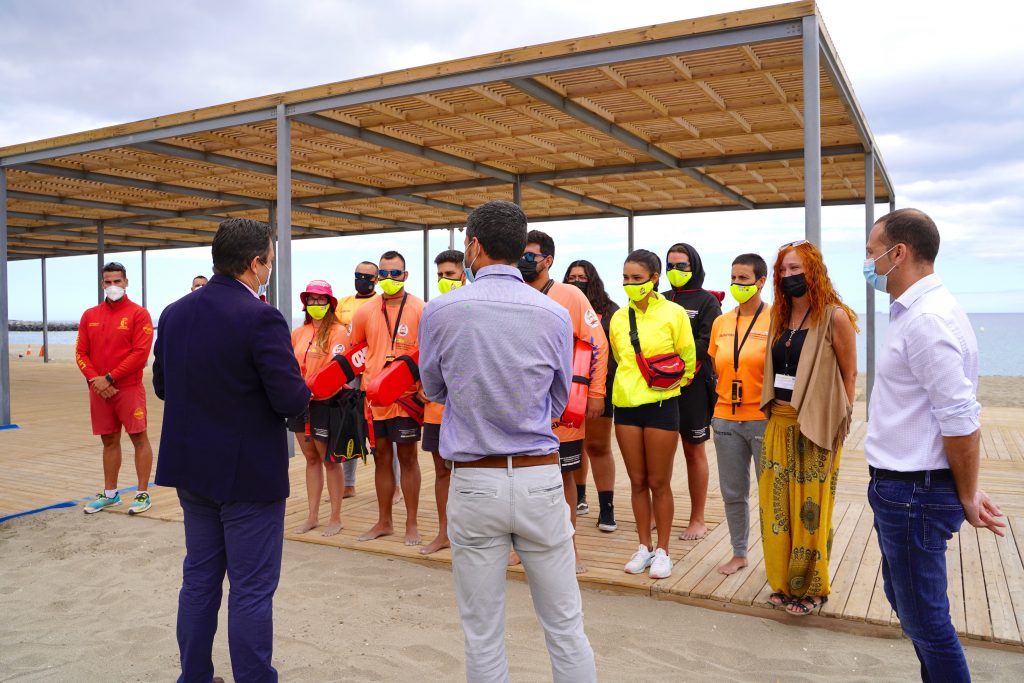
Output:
[0, 358, 1024, 651]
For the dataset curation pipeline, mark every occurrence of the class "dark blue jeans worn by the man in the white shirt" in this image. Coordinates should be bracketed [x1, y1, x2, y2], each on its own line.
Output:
[867, 477, 971, 683]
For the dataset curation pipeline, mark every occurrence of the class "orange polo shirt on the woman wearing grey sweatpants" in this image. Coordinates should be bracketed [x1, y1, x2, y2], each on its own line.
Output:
[708, 303, 771, 422]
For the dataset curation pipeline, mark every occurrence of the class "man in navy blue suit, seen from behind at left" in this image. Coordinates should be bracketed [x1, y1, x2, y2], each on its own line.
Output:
[153, 218, 309, 683]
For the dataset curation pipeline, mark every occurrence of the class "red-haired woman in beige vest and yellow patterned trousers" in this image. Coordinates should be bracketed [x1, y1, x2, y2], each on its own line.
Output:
[758, 240, 857, 615]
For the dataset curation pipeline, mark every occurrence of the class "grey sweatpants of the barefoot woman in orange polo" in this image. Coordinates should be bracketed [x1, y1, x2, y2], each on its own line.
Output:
[711, 418, 768, 557]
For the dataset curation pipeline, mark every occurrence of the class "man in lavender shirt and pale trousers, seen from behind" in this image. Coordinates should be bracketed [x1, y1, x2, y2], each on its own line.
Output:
[420, 202, 597, 683]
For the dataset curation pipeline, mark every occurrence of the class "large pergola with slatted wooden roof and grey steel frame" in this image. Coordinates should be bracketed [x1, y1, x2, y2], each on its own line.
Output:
[0, 2, 895, 425]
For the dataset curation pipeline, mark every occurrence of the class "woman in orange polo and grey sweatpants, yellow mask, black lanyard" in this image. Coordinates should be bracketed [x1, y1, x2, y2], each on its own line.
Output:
[708, 254, 771, 574]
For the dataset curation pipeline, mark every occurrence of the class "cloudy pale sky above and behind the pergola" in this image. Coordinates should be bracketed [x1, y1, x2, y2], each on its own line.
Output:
[0, 0, 1024, 319]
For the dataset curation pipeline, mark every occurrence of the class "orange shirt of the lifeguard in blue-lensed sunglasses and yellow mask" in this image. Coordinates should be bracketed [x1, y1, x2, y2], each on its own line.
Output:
[349, 293, 423, 420]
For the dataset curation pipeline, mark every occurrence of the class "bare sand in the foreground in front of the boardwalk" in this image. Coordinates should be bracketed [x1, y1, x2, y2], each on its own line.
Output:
[0, 508, 1024, 682]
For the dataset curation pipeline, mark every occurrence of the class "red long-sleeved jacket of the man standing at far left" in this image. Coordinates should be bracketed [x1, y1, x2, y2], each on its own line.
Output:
[75, 296, 153, 387]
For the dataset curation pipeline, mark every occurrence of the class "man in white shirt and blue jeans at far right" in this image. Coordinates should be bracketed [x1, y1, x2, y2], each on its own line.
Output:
[864, 209, 1006, 681]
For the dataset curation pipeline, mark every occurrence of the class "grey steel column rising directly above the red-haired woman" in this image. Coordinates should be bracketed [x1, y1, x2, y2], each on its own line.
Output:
[803, 14, 821, 248]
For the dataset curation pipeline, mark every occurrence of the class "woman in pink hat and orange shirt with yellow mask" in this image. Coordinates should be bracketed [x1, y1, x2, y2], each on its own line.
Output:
[288, 280, 348, 536]
